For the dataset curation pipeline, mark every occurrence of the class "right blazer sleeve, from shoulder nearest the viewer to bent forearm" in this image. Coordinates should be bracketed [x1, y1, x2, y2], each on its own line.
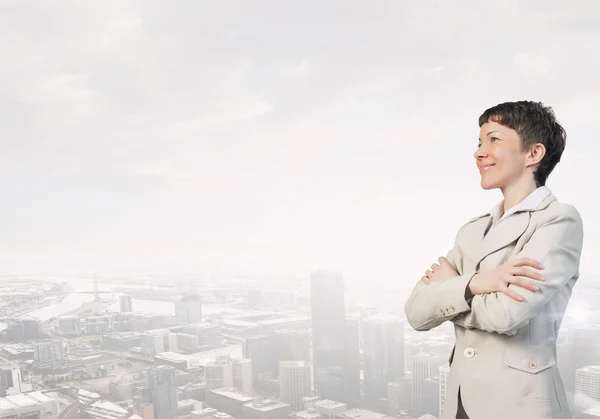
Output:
[452, 204, 583, 336]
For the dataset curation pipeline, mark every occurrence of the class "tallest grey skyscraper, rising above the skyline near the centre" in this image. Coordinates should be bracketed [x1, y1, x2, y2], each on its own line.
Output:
[310, 271, 346, 402]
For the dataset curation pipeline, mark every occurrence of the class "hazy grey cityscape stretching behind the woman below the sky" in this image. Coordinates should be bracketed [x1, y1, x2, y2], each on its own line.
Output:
[0, 270, 600, 419]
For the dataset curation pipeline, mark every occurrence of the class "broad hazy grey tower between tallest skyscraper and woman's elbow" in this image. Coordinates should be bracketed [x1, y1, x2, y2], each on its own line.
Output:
[361, 313, 404, 411]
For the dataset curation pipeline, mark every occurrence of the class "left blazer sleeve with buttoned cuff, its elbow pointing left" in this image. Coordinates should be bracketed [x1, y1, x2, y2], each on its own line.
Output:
[404, 226, 475, 331]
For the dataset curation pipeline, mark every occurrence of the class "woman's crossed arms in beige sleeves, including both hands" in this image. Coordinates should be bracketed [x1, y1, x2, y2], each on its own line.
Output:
[405, 205, 583, 336]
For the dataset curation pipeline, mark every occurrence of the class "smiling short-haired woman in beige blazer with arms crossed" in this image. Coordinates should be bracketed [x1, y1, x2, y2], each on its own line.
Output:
[405, 101, 583, 419]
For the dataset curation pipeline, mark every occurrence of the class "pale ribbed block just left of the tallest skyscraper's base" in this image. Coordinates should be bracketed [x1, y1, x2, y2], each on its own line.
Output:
[279, 361, 311, 412]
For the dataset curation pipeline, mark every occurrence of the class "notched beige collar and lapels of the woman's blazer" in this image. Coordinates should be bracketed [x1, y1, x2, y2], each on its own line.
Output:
[463, 193, 556, 265]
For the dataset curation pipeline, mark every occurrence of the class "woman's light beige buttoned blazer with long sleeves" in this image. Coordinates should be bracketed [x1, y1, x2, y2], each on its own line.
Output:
[405, 194, 583, 419]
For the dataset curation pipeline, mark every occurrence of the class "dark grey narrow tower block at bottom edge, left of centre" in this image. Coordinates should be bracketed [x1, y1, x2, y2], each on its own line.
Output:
[148, 365, 177, 419]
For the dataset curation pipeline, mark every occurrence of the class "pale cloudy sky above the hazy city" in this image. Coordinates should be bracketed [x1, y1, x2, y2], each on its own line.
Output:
[0, 0, 600, 283]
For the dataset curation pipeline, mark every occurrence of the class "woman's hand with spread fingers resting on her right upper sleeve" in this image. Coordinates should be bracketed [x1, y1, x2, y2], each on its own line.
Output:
[466, 258, 544, 301]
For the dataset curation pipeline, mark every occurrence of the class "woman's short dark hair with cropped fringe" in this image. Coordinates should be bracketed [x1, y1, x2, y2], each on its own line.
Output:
[479, 101, 567, 187]
